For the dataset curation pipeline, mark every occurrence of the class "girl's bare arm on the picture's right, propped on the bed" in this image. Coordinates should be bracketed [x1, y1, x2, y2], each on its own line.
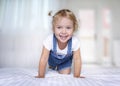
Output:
[73, 49, 82, 77]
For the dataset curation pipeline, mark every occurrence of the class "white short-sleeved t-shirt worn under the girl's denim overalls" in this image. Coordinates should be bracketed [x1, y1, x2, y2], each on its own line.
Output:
[43, 34, 80, 54]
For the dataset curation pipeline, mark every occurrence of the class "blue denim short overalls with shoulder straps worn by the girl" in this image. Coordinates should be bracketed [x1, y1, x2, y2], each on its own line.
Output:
[48, 35, 73, 71]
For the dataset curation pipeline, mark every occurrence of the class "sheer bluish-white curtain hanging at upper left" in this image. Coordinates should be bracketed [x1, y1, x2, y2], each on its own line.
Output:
[0, 0, 49, 34]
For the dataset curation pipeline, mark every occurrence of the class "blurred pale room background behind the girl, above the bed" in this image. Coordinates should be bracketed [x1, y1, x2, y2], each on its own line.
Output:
[0, 0, 120, 68]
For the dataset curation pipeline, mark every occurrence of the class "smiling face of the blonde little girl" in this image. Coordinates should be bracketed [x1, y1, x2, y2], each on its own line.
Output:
[53, 17, 74, 43]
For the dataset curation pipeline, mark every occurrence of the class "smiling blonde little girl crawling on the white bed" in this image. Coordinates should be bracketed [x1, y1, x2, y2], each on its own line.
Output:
[36, 9, 81, 78]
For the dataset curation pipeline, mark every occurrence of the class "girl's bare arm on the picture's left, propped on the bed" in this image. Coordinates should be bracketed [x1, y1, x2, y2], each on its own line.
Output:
[37, 47, 49, 78]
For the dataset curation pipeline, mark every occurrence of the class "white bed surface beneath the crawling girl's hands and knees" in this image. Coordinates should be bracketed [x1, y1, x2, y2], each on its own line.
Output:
[0, 67, 120, 86]
